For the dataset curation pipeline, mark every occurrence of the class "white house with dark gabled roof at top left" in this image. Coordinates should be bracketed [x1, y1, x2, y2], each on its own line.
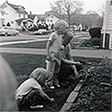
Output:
[1, 1, 28, 28]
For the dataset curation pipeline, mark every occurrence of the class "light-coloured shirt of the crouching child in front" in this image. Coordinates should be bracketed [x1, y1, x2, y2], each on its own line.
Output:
[15, 78, 42, 99]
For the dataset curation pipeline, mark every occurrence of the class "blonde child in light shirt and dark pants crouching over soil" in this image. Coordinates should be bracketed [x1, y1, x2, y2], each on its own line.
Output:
[15, 68, 54, 110]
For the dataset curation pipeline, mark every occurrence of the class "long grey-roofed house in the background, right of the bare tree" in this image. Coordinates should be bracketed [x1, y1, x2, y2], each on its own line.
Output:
[70, 13, 102, 30]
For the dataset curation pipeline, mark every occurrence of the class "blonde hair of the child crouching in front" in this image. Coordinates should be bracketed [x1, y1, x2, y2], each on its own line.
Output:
[30, 67, 47, 85]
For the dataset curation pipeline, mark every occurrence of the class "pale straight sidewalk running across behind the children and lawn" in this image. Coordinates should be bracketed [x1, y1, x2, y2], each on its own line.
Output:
[0, 47, 112, 59]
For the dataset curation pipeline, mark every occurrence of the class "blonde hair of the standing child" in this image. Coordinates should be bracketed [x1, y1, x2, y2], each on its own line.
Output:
[54, 20, 69, 30]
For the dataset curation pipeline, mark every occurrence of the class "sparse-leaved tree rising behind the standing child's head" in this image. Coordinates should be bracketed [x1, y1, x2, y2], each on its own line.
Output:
[50, 0, 83, 26]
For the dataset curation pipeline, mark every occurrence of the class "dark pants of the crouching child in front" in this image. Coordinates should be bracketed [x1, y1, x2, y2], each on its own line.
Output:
[17, 89, 43, 111]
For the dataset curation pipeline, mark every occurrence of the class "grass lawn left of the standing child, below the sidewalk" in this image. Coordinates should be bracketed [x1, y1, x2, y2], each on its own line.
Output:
[2, 53, 45, 84]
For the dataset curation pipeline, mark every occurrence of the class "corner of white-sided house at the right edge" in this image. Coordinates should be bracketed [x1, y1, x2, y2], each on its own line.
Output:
[102, 0, 112, 49]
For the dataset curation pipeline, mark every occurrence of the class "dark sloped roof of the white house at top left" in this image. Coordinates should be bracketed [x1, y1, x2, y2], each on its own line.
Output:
[6, 2, 28, 14]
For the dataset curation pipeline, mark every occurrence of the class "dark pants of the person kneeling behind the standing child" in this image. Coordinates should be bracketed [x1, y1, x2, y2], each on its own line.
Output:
[58, 63, 82, 81]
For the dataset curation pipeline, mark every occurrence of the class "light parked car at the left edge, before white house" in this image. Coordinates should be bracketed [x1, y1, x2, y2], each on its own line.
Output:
[0, 27, 19, 36]
